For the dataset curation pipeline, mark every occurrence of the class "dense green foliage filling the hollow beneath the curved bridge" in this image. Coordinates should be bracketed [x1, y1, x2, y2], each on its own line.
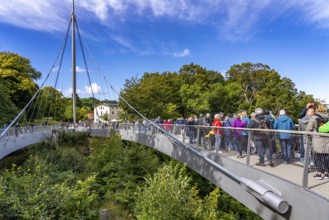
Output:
[0, 132, 259, 219]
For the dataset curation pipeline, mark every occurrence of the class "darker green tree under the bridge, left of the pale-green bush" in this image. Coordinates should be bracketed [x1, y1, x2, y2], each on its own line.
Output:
[88, 136, 159, 210]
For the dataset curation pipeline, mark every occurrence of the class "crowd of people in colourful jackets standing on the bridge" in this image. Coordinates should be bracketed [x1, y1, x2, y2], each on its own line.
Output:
[144, 103, 329, 179]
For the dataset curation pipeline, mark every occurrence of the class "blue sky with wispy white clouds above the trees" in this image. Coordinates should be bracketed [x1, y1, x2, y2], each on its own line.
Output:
[0, 0, 329, 103]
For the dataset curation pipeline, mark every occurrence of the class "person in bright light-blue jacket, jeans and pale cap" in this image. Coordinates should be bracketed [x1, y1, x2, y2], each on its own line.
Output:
[273, 109, 295, 164]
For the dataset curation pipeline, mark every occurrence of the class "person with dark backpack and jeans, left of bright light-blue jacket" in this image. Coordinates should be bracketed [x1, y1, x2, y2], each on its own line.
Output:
[247, 108, 274, 167]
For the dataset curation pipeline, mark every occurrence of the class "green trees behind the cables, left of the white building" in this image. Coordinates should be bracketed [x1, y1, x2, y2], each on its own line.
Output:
[0, 52, 115, 125]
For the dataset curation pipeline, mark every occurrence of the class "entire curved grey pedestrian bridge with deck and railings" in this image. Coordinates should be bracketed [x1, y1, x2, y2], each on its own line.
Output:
[0, 124, 329, 220]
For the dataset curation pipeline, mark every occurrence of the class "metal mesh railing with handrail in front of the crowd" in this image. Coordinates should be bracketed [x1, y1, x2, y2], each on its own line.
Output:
[118, 123, 329, 199]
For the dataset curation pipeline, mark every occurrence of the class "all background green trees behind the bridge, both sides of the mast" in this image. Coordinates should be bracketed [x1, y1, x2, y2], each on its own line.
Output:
[0, 49, 318, 125]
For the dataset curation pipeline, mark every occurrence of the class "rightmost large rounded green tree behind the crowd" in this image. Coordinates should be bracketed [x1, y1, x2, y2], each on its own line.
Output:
[226, 63, 312, 119]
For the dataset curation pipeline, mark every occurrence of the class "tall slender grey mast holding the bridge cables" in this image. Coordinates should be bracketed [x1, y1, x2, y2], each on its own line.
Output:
[71, 0, 77, 126]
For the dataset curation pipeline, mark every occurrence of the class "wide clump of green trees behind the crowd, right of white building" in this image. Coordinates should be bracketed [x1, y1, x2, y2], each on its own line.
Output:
[121, 63, 314, 119]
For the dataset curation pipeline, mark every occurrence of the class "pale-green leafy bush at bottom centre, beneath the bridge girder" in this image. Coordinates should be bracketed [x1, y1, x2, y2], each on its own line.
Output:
[135, 163, 219, 219]
